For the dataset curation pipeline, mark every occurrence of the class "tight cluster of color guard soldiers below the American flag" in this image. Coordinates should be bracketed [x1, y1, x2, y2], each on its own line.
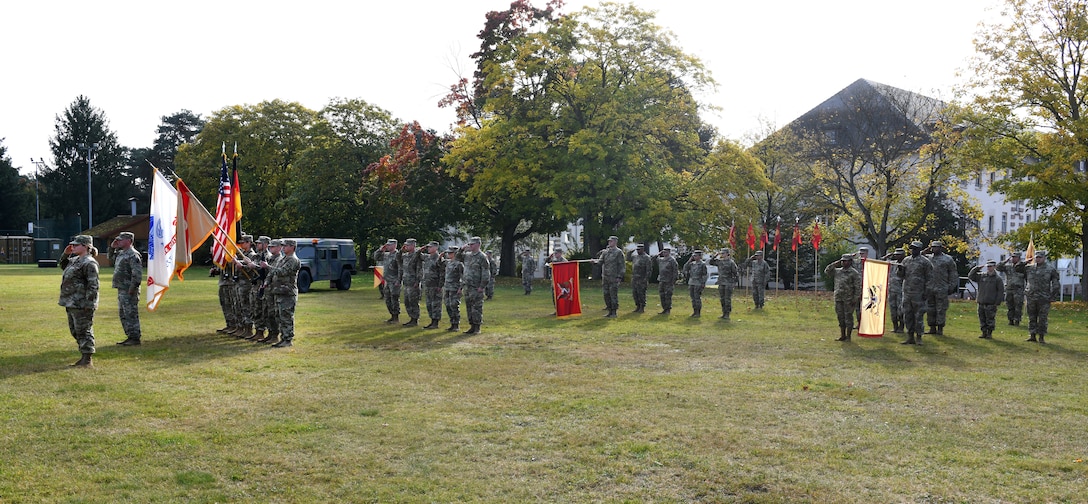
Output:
[215, 234, 301, 348]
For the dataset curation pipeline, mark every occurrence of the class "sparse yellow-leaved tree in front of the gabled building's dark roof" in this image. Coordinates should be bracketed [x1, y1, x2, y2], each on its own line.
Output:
[788, 79, 970, 260]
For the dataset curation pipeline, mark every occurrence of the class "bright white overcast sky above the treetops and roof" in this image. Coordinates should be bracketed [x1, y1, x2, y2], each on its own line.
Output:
[0, 0, 1000, 173]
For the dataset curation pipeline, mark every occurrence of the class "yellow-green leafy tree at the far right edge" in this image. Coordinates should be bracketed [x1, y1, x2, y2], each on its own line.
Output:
[964, 0, 1088, 292]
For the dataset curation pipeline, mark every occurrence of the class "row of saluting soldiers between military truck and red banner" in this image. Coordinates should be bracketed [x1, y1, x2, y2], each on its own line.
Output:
[373, 236, 491, 334]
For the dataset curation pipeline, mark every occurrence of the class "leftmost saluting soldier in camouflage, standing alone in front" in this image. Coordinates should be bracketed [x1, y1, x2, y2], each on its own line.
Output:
[58, 234, 98, 367]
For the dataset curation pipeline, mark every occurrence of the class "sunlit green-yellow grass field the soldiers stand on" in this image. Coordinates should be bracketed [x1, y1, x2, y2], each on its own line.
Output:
[0, 266, 1088, 503]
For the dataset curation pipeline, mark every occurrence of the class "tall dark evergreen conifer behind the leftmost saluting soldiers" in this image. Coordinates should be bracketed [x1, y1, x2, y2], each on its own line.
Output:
[41, 95, 130, 229]
